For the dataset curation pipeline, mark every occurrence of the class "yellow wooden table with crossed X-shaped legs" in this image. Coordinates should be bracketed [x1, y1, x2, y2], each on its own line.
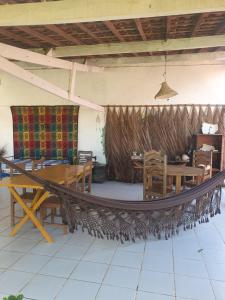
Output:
[0, 164, 87, 243]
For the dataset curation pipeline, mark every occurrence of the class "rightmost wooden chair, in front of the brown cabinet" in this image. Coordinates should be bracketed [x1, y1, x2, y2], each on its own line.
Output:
[184, 150, 213, 187]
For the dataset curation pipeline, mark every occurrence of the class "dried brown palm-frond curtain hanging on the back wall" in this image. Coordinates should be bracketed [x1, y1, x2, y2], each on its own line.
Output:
[105, 105, 225, 182]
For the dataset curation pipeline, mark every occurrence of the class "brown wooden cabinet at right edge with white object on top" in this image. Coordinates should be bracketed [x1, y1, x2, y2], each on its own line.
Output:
[195, 134, 225, 173]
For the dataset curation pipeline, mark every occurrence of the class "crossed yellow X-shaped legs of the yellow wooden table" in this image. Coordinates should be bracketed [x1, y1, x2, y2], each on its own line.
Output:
[9, 187, 53, 243]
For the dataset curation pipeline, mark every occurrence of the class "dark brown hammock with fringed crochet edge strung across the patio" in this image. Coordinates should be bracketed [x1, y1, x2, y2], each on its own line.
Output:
[0, 157, 225, 242]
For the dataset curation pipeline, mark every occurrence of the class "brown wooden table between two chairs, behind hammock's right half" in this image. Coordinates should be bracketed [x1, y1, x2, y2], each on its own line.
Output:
[167, 165, 203, 193]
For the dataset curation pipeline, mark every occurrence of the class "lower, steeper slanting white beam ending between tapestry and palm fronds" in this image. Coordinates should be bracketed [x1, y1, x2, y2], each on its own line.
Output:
[0, 56, 104, 111]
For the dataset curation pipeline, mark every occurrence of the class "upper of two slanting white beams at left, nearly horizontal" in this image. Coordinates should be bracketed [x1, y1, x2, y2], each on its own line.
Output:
[0, 43, 103, 72]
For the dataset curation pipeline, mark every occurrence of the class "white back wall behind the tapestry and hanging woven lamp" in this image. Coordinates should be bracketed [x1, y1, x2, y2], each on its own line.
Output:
[0, 55, 225, 161]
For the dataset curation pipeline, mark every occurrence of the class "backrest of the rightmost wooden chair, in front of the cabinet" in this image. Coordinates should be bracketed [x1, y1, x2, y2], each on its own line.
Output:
[192, 150, 213, 180]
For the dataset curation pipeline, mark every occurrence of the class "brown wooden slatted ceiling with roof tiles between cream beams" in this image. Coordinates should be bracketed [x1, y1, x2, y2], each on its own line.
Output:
[0, 0, 225, 57]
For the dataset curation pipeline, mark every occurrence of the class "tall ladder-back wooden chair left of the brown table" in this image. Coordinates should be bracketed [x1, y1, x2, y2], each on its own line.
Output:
[143, 150, 173, 200]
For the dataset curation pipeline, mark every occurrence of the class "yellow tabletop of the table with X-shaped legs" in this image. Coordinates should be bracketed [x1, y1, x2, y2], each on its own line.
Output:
[0, 164, 84, 189]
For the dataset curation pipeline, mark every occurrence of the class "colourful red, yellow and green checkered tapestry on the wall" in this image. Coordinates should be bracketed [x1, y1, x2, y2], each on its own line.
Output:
[11, 105, 79, 161]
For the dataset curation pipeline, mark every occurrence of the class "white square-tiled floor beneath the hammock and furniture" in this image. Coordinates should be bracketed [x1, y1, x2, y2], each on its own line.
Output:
[0, 182, 225, 300]
